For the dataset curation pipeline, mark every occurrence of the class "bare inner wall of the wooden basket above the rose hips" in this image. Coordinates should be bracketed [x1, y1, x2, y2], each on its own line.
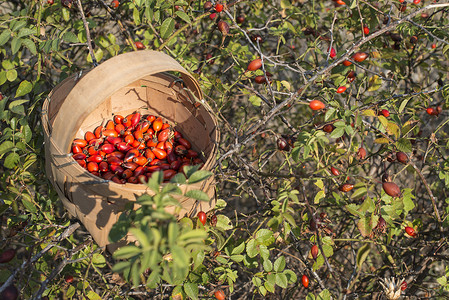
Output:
[60, 73, 216, 160]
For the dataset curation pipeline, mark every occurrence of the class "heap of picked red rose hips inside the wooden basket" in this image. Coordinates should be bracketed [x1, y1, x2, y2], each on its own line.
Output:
[72, 112, 203, 184]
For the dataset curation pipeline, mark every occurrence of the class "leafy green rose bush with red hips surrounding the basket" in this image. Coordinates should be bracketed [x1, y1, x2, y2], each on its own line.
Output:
[0, 0, 449, 299]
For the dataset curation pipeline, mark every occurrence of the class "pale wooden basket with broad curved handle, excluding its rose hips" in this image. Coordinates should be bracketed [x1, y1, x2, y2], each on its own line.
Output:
[42, 51, 219, 247]
